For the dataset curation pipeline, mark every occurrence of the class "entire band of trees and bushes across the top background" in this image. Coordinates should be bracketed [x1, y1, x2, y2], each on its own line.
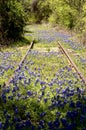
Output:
[0, 0, 86, 44]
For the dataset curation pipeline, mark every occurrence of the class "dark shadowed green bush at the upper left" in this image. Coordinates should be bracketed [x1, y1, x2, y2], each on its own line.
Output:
[0, 0, 26, 43]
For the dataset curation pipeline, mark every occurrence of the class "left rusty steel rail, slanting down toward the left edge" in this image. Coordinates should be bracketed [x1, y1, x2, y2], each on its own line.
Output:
[3, 41, 34, 87]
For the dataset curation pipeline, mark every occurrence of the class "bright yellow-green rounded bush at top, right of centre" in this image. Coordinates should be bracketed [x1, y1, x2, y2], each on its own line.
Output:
[49, 0, 77, 29]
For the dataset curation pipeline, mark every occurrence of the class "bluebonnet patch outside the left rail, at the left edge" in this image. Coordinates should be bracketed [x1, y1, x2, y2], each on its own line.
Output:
[0, 49, 21, 77]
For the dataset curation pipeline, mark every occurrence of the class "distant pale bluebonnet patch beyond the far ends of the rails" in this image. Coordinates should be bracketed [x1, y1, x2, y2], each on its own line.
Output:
[25, 30, 83, 50]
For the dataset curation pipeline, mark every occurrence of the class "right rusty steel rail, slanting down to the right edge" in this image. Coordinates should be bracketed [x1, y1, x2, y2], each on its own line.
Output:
[58, 41, 86, 85]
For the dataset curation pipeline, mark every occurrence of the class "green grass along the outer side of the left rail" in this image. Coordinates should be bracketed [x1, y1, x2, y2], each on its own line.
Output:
[0, 37, 32, 85]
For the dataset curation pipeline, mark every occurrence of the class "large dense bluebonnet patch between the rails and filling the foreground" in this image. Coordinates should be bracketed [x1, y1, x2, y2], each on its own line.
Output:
[0, 51, 86, 130]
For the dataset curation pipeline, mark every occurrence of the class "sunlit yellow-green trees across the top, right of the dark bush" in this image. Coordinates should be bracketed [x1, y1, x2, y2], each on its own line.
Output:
[26, 0, 86, 31]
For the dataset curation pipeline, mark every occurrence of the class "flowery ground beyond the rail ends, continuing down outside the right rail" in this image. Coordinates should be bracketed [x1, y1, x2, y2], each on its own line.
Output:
[26, 24, 86, 76]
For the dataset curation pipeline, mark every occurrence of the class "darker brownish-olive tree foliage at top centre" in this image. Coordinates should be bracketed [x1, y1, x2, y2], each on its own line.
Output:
[31, 0, 52, 23]
